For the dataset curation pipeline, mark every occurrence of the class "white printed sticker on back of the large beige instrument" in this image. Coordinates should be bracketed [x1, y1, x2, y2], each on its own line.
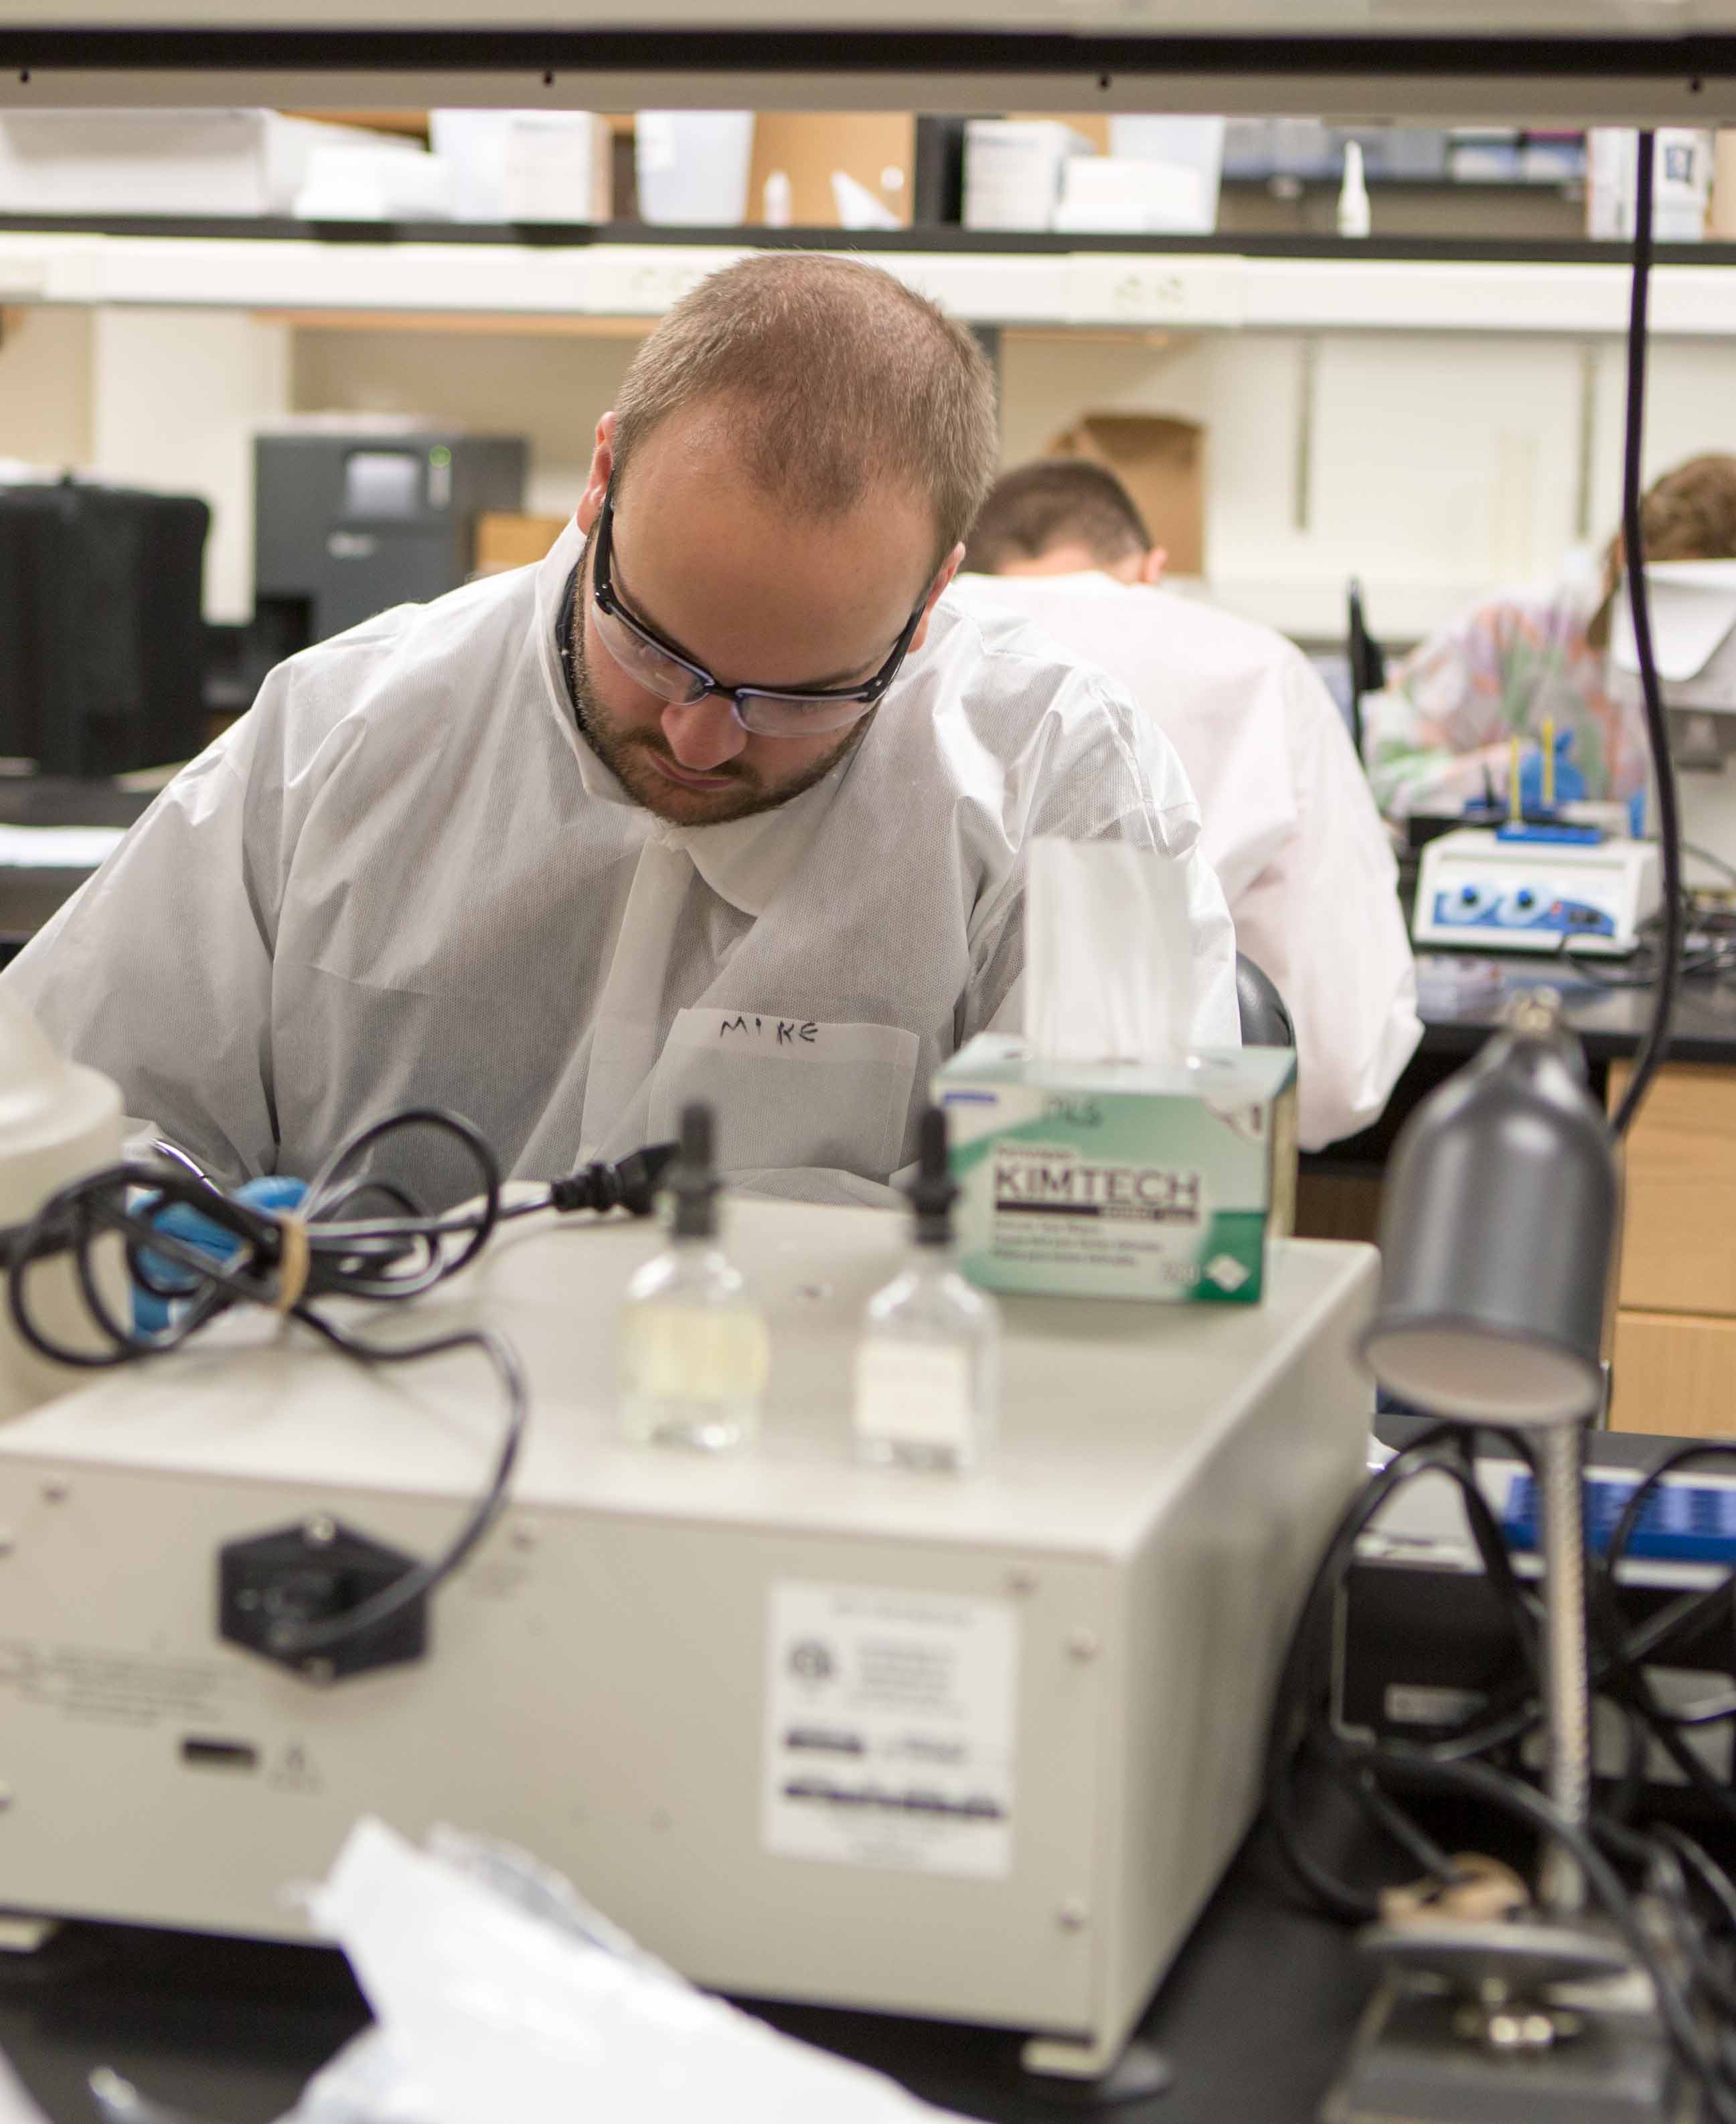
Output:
[761, 1580, 1018, 1880]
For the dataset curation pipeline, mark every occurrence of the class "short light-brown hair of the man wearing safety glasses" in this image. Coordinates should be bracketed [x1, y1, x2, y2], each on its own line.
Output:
[614, 253, 999, 567]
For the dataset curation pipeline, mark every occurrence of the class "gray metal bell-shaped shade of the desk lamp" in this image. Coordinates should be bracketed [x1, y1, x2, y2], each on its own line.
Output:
[1362, 998, 1619, 1423]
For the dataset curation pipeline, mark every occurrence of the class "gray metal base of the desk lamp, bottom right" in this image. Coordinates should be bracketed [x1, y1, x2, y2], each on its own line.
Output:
[1320, 1977, 1685, 2124]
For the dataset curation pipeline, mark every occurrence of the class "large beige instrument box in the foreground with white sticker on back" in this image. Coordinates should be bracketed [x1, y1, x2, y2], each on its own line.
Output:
[0, 1200, 1377, 2075]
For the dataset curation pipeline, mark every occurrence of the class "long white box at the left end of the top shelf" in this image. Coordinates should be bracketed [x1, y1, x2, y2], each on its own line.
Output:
[0, 110, 406, 219]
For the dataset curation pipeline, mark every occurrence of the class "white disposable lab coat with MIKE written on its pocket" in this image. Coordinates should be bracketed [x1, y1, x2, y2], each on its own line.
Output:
[4, 525, 1237, 1200]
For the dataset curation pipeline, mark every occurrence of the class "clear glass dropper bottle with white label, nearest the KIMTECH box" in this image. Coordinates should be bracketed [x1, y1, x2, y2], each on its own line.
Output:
[856, 1107, 1001, 1472]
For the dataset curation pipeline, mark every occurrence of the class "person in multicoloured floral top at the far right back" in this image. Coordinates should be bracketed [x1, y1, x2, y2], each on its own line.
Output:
[1362, 457, 1736, 820]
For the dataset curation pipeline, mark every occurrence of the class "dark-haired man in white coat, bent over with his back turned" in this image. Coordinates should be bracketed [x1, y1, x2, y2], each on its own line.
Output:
[960, 459, 1421, 1149]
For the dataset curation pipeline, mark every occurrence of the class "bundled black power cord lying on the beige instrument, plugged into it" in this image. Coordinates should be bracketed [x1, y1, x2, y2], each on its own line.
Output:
[0, 1107, 674, 1665]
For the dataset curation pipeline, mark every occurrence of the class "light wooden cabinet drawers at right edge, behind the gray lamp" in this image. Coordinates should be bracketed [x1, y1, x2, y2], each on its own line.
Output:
[1609, 1062, 1736, 1438]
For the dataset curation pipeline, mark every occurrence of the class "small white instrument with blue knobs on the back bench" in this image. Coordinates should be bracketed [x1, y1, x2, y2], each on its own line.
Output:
[1411, 826, 1660, 958]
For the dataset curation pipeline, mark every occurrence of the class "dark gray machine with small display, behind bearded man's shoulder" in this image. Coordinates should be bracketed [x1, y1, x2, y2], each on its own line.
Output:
[253, 427, 527, 663]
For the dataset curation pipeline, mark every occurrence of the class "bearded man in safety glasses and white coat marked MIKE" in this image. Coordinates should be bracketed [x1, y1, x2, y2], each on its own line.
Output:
[4, 255, 1237, 1200]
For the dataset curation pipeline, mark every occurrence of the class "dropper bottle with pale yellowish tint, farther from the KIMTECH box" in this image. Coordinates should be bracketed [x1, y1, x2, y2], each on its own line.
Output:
[619, 1105, 769, 1453]
